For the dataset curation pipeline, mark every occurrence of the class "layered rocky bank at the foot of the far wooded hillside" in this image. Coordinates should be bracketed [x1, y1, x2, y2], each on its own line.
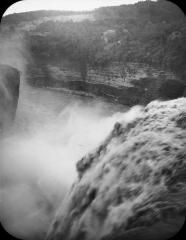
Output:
[27, 60, 185, 106]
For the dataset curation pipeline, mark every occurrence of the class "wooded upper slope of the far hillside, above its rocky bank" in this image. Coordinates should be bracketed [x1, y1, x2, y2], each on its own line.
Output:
[2, 0, 186, 104]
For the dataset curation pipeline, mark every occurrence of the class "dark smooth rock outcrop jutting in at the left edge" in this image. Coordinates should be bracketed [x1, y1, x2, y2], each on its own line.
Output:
[0, 64, 20, 130]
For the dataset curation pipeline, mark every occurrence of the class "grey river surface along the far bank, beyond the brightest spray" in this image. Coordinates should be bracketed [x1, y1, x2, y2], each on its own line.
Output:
[14, 84, 128, 135]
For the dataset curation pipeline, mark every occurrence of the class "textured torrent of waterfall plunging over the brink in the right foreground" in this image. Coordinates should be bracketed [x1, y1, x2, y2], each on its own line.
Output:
[47, 98, 186, 240]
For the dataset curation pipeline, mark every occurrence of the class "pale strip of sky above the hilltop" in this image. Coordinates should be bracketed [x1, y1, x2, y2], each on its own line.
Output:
[4, 0, 151, 15]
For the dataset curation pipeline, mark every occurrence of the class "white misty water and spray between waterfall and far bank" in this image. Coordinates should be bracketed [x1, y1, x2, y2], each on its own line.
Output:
[0, 81, 126, 239]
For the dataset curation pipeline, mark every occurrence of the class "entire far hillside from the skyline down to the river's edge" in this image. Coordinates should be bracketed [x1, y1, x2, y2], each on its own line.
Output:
[1, 1, 186, 106]
